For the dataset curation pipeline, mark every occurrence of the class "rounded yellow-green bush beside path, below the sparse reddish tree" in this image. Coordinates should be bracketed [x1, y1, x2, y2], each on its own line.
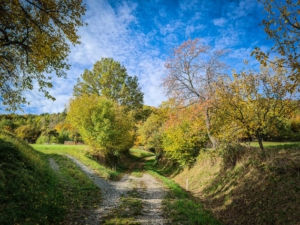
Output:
[161, 104, 208, 166]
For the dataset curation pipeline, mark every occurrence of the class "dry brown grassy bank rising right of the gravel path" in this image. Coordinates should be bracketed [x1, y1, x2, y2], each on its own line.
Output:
[170, 144, 300, 225]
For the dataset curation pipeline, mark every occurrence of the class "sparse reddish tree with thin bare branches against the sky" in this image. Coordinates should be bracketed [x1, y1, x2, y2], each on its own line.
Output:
[163, 39, 225, 148]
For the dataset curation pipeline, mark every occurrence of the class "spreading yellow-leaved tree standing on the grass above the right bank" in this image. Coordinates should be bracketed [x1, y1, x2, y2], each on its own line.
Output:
[217, 61, 296, 150]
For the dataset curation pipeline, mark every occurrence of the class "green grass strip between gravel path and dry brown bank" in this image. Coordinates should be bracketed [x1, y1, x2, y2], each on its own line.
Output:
[145, 158, 221, 224]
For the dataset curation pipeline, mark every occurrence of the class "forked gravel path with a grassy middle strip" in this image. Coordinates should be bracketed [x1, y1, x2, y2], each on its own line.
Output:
[66, 155, 166, 225]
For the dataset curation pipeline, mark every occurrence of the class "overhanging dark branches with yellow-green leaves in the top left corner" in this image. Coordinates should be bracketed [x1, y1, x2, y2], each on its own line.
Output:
[0, 0, 85, 111]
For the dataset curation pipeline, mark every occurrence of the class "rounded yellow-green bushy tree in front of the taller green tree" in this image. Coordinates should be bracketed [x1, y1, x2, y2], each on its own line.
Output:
[67, 95, 134, 163]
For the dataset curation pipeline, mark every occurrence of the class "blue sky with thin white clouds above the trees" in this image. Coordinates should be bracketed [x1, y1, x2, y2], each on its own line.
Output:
[0, 0, 272, 114]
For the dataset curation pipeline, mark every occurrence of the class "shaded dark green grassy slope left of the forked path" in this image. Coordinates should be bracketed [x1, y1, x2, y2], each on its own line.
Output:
[0, 132, 101, 224]
